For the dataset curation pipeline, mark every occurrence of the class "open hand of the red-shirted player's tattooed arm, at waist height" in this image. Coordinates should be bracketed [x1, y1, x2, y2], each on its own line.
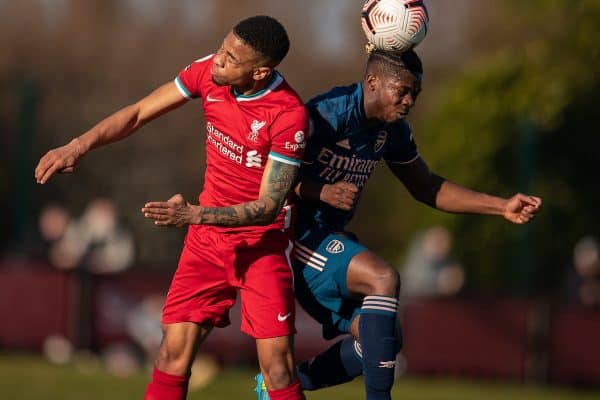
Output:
[142, 194, 197, 228]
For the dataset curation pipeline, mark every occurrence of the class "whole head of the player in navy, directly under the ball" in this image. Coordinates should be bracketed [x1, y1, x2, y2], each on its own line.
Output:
[363, 50, 423, 123]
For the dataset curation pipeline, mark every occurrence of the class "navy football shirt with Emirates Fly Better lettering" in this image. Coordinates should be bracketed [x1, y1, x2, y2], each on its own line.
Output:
[298, 83, 418, 231]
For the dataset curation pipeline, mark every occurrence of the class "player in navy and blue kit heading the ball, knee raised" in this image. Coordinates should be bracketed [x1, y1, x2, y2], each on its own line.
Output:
[257, 50, 542, 400]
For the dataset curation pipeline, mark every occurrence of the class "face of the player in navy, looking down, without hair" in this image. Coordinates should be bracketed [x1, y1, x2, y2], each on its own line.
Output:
[374, 71, 421, 123]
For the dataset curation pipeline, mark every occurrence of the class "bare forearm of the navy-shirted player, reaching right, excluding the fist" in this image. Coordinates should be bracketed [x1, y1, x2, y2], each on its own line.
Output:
[435, 180, 507, 215]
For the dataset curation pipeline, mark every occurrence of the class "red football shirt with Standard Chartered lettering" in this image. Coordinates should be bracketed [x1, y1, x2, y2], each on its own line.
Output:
[175, 55, 308, 231]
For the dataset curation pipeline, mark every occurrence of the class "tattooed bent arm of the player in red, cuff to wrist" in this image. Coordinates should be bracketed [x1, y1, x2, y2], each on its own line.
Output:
[200, 160, 298, 226]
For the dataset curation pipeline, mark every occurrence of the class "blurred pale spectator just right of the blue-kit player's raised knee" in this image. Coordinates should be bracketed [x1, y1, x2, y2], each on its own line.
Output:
[401, 226, 465, 297]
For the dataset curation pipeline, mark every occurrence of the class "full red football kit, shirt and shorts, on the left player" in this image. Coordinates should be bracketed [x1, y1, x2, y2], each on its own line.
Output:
[162, 55, 308, 338]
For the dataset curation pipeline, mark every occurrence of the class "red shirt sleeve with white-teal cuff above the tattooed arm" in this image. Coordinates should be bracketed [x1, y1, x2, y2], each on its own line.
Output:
[269, 106, 308, 167]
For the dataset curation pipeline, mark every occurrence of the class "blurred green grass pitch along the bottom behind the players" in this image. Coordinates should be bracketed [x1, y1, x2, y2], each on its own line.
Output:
[0, 354, 600, 400]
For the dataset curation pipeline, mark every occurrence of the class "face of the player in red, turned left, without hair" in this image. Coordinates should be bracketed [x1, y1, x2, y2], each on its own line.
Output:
[211, 32, 261, 91]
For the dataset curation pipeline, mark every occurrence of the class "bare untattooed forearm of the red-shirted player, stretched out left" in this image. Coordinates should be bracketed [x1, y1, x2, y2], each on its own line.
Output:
[75, 104, 143, 155]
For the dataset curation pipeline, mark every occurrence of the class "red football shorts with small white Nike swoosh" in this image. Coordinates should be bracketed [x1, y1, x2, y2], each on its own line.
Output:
[162, 225, 296, 339]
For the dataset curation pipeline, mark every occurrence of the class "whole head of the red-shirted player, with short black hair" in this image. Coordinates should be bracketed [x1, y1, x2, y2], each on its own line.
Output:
[211, 15, 290, 88]
